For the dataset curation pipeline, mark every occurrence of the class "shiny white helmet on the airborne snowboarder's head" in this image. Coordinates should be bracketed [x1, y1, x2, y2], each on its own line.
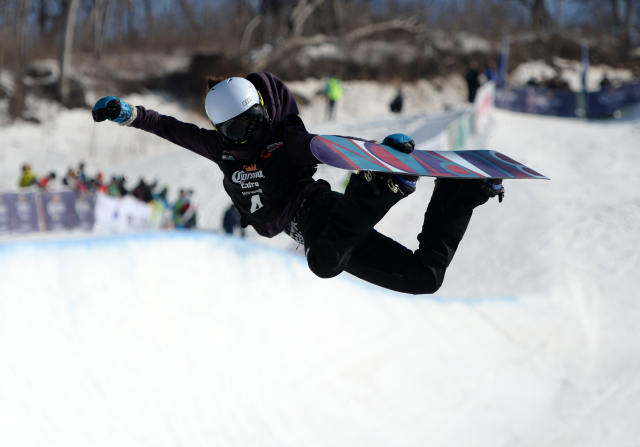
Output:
[204, 78, 260, 125]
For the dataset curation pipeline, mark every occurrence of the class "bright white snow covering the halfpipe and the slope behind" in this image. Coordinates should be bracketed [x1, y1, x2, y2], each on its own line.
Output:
[0, 81, 640, 447]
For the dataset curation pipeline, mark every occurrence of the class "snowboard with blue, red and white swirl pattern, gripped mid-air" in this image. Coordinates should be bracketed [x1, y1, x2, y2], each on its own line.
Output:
[311, 135, 549, 180]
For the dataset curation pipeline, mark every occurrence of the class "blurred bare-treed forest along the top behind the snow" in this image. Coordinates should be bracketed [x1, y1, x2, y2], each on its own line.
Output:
[0, 0, 640, 116]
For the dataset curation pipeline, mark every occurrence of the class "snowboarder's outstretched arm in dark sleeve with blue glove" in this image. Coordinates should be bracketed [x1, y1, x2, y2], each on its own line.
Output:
[92, 96, 220, 161]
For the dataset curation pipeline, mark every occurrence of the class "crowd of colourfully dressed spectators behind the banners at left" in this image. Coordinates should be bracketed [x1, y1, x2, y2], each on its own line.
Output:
[18, 162, 197, 228]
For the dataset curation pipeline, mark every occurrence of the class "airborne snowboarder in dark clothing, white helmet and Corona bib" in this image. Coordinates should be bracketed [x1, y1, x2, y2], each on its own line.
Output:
[92, 73, 502, 294]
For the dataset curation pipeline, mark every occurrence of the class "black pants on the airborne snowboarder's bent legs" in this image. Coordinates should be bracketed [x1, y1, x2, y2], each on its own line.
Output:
[299, 175, 488, 294]
